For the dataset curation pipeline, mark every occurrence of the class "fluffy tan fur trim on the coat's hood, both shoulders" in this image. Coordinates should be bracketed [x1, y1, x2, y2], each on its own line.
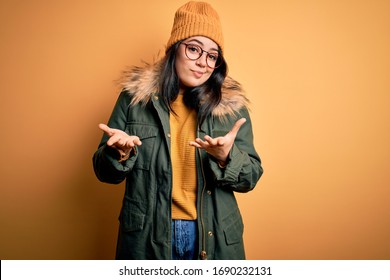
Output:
[121, 61, 249, 119]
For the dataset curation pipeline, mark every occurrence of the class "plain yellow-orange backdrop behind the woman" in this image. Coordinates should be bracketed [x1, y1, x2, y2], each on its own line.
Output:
[0, 0, 390, 259]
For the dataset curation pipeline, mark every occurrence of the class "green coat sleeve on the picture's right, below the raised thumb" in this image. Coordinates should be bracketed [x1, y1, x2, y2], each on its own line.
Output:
[210, 109, 263, 192]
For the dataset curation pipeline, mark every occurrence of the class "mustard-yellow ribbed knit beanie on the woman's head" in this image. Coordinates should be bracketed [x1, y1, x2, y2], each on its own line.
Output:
[166, 1, 223, 52]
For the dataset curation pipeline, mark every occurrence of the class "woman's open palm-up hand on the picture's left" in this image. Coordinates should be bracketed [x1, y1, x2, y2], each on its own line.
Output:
[99, 123, 142, 161]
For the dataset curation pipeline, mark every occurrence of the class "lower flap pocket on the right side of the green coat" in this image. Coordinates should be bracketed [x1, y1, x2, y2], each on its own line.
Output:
[223, 209, 244, 245]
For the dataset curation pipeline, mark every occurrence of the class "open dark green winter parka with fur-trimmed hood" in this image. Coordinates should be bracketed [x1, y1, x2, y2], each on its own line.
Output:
[93, 60, 263, 259]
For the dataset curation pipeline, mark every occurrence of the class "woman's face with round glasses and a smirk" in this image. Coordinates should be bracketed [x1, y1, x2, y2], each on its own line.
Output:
[175, 36, 218, 93]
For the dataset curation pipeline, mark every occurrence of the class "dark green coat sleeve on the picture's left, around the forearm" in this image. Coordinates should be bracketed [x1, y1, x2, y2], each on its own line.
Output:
[92, 91, 138, 184]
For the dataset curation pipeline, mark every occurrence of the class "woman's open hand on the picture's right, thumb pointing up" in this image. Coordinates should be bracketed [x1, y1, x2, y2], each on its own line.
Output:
[190, 118, 246, 166]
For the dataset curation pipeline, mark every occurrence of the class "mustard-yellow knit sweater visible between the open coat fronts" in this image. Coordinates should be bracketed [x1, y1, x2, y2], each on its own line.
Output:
[170, 95, 197, 220]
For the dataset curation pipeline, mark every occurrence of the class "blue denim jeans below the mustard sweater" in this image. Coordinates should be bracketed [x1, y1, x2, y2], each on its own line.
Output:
[172, 220, 198, 260]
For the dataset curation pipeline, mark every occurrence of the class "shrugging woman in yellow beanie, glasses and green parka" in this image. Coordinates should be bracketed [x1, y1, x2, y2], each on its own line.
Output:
[93, 1, 263, 259]
